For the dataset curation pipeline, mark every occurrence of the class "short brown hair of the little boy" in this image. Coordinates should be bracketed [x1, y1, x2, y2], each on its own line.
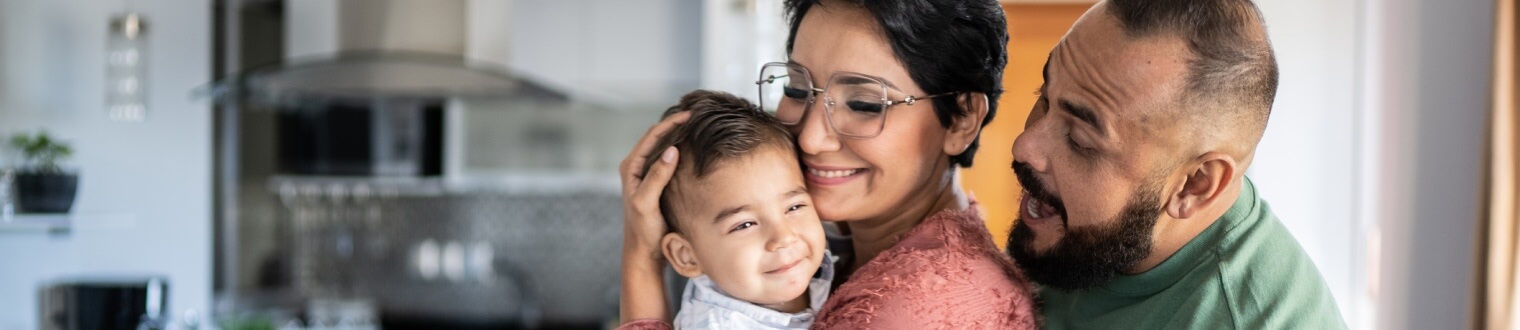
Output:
[643, 90, 796, 233]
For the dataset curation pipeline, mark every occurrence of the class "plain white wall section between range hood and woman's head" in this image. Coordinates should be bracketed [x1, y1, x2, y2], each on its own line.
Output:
[503, 0, 702, 107]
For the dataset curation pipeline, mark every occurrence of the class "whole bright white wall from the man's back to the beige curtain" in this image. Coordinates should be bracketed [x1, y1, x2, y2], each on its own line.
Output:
[1251, 0, 1493, 328]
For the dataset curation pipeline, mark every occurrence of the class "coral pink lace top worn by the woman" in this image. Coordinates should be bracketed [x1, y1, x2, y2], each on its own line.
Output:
[619, 207, 1038, 330]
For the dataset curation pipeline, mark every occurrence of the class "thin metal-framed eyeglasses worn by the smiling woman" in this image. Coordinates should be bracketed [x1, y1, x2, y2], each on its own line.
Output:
[755, 62, 959, 138]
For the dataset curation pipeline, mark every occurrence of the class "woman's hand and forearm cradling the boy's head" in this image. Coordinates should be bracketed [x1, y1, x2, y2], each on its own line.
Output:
[617, 111, 692, 322]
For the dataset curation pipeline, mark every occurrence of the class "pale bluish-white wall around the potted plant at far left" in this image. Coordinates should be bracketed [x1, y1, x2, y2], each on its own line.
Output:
[0, 0, 211, 328]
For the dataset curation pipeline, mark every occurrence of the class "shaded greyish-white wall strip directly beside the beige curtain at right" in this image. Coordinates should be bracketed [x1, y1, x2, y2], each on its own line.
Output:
[1359, 0, 1494, 328]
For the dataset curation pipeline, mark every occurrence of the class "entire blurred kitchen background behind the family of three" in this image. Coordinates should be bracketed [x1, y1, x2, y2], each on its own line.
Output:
[0, 0, 1512, 328]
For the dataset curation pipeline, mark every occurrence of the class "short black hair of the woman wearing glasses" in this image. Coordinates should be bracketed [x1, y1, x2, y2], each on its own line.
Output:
[786, 0, 1008, 167]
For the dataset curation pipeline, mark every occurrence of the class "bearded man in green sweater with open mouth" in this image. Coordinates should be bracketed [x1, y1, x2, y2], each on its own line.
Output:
[1008, 0, 1345, 328]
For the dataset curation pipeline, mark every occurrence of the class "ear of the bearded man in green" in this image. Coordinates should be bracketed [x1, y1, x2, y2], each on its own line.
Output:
[1166, 152, 1239, 219]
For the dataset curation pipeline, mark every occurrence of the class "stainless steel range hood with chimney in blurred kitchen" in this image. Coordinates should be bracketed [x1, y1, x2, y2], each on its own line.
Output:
[207, 0, 568, 108]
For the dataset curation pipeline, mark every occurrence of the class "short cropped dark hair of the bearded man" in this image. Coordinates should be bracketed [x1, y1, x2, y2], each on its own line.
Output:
[1108, 0, 1277, 137]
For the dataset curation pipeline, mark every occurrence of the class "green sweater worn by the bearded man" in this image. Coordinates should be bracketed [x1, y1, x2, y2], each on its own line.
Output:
[1040, 179, 1345, 328]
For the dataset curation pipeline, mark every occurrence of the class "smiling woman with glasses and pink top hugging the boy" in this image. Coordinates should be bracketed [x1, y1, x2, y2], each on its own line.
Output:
[620, 0, 1035, 328]
